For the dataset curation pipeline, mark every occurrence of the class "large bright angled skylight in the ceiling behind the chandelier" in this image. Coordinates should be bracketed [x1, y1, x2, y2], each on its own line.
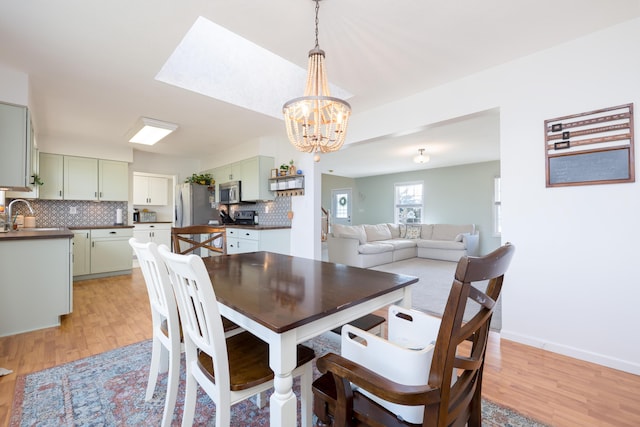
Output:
[156, 16, 353, 119]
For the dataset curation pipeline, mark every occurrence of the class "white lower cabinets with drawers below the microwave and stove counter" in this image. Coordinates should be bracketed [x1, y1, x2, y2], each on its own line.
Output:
[226, 227, 291, 255]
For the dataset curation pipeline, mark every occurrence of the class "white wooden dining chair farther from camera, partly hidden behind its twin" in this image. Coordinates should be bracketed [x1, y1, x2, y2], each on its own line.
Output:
[129, 237, 182, 427]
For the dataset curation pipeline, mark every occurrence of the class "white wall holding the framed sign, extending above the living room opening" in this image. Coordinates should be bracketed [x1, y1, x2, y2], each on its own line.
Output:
[349, 19, 640, 374]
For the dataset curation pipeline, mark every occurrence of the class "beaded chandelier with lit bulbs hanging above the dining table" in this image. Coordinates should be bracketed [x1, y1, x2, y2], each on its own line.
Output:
[282, 0, 351, 162]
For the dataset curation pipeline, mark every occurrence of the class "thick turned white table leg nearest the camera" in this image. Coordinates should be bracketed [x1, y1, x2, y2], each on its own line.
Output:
[269, 333, 298, 427]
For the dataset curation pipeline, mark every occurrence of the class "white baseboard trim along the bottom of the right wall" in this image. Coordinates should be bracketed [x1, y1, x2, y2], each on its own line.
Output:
[500, 329, 640, 375]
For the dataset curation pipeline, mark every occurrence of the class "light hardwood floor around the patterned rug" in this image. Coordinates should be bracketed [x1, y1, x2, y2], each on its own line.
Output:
[0, 269, 640, 427]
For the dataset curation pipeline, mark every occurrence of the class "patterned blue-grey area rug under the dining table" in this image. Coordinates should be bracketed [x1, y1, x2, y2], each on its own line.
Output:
[10, 333, 543, 427]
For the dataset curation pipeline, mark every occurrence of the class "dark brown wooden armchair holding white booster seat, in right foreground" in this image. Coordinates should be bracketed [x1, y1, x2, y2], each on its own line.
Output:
[313, 243, 515, 427]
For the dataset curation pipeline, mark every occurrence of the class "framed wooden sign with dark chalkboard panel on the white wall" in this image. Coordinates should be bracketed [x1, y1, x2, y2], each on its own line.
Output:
[544, 103, 635, 187]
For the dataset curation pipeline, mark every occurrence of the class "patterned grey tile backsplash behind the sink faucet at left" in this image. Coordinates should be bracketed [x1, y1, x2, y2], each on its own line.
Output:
[7, 200, 129, 231]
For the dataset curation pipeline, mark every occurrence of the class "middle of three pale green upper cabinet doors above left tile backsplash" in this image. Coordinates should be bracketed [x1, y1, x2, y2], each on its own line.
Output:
[64, 156, 98, 200]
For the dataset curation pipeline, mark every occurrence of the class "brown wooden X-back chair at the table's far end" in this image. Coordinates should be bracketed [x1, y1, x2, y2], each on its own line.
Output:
[171, 225, 227, 255]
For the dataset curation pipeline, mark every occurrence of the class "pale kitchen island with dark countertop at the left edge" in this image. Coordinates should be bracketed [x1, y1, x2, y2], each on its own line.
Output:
[0, 228, 73, 336]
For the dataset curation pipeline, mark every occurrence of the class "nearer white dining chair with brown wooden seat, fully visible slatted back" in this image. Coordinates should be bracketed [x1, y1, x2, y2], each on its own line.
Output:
[159, 246, 315, 427]
